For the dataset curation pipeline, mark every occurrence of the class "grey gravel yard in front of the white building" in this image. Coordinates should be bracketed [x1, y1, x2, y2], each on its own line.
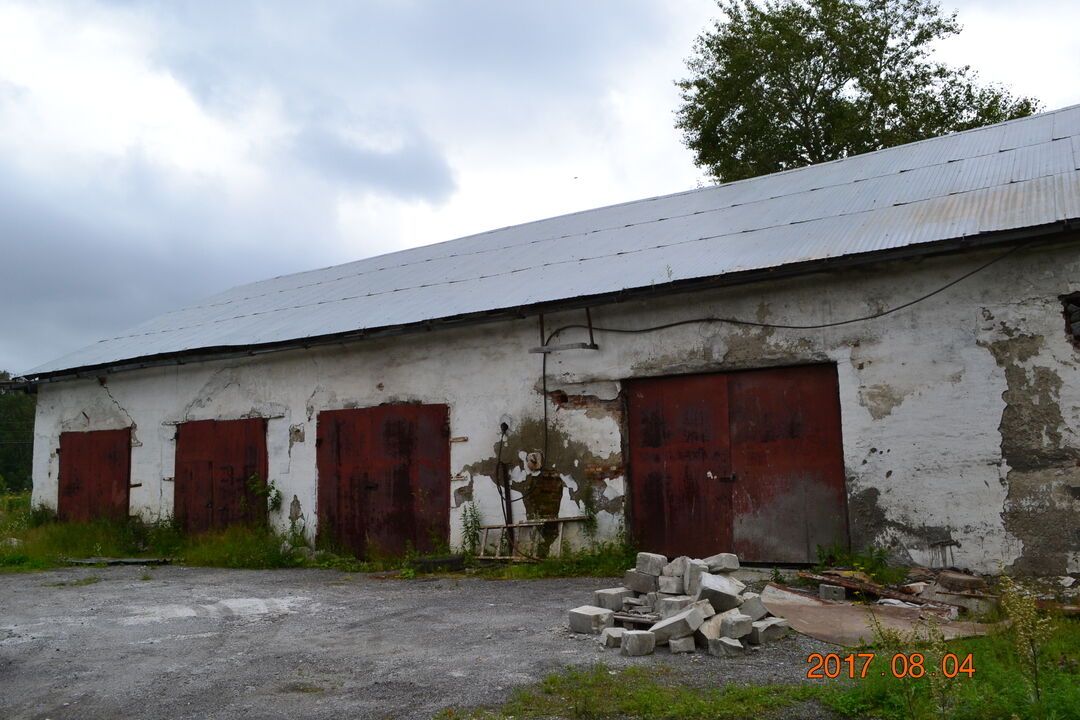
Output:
[0, 567, 835, 720]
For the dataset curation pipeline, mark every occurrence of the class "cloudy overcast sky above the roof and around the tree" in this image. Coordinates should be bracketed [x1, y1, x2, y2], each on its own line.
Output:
[0, 0, 1080, 371]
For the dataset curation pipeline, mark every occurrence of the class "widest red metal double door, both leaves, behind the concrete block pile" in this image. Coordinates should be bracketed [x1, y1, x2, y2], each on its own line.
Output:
[627, 365, 848, 562]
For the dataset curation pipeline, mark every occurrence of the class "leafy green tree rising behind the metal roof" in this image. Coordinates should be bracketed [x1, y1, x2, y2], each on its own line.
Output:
[676, 0, 1038, 181]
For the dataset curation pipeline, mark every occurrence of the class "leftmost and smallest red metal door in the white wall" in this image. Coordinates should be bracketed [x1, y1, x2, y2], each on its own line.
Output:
[56, 427, 132, 522]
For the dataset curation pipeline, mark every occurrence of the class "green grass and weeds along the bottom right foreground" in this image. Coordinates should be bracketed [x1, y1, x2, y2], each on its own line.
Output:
[437, 617, 1080, 720]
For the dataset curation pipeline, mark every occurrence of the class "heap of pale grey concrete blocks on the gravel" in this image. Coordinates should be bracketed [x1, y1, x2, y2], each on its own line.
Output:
[570, 553, 789, 656]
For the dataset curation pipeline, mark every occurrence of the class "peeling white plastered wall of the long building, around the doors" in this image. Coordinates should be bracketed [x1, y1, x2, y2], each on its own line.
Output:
[33, 245, 1080, 572]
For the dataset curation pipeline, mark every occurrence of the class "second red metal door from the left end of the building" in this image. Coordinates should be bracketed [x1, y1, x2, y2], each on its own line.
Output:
[174, 418, 268, 533]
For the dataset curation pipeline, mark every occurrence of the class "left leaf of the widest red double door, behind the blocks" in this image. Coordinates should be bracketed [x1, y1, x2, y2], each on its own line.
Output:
[629, 375, 731, 557]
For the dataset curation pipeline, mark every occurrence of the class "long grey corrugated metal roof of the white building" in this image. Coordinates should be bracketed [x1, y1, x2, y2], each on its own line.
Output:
[28, 106, 1080, 377]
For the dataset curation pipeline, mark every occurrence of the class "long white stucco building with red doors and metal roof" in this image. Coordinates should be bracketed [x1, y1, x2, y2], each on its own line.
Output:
[27, 106, 1080, 573]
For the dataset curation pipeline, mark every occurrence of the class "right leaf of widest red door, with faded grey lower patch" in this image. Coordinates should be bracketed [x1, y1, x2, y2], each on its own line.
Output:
[729, 365, 848, 562]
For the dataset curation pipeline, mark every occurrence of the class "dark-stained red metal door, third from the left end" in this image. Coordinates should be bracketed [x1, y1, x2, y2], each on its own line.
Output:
[315, 405, 450, 557]
